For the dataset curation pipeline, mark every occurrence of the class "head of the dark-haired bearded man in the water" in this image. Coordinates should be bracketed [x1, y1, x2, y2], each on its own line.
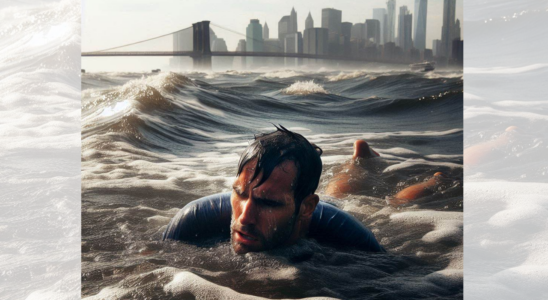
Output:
[230, 126, 322, 254]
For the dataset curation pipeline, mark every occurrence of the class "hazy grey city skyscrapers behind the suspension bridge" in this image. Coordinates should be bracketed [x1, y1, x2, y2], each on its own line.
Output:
[170, 0, 463, 69]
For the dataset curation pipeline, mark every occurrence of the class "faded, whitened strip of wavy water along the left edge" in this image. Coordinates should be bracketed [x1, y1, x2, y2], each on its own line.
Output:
[0, 1, 81, 300]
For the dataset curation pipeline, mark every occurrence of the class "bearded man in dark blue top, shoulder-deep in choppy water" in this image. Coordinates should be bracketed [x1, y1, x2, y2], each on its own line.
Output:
[163, 126, 384, 254]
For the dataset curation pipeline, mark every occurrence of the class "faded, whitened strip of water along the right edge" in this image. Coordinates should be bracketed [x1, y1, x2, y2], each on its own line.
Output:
[464, 0, 548, 299]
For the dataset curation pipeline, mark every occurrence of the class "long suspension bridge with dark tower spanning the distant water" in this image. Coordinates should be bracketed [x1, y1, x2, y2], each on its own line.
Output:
[82, 21, 394, 69]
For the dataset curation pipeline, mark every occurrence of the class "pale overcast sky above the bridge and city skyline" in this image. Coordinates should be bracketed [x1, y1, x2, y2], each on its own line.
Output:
[82, 0, 464, 51]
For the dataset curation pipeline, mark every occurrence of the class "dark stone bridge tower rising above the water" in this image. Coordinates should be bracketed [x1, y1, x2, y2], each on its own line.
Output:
[192, 21, 211, 70]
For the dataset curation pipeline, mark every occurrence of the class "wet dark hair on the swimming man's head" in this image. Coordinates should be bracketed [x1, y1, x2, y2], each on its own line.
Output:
[236, 124, 323, 214]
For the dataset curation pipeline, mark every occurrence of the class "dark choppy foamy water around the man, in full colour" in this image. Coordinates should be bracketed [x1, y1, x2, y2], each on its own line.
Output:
[82, 69, 463, 299]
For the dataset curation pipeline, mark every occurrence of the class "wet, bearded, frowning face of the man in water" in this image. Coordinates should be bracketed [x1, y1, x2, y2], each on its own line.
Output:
[230, 160, 297, 254]
